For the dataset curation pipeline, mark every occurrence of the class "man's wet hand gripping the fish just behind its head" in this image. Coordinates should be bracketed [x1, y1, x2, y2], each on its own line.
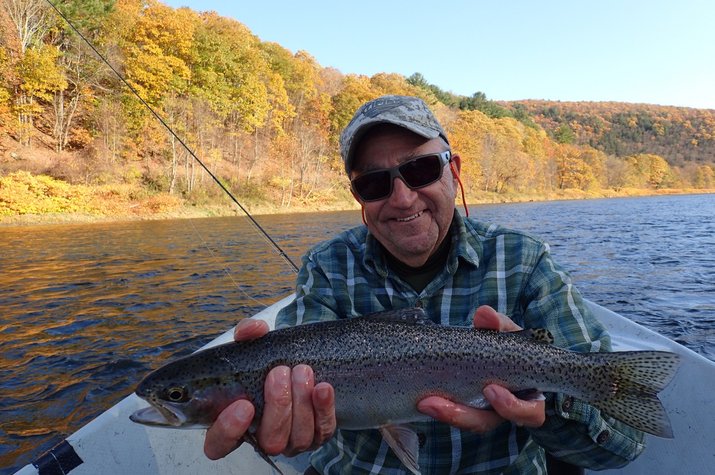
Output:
[204, 319, 335, 460]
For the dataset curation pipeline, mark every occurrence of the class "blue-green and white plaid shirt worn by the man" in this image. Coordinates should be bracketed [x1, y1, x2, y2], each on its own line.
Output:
[277, 212, 645, 475]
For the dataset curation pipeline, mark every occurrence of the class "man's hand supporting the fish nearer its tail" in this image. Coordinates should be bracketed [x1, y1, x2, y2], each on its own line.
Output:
[417, 305, 546, 432]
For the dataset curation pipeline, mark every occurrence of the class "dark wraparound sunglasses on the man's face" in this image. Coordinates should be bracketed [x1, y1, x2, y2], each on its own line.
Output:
[350, 150, 452, 201]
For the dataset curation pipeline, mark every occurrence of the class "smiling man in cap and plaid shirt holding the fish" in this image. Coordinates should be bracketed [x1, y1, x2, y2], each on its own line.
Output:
[205, 96, 644, 473]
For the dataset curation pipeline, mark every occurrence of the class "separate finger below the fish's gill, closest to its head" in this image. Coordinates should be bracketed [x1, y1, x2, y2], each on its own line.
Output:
[204, 399, 255, 460]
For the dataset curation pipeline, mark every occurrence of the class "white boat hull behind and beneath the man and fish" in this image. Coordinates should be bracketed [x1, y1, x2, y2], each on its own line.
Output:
[17, 297, 715, 475]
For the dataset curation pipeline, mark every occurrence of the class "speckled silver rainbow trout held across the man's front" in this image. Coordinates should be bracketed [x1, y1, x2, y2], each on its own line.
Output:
[131, 308, 679, 473]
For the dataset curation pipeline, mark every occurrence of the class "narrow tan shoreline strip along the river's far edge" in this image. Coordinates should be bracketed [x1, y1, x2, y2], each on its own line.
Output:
[0, 189, 715, 228]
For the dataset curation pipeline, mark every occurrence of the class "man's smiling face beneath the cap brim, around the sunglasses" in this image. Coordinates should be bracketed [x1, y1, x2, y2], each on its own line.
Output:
[351, 126, 460, 267]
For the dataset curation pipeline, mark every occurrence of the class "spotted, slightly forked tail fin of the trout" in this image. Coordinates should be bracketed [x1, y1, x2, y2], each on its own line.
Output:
[592, 351, 680, 438]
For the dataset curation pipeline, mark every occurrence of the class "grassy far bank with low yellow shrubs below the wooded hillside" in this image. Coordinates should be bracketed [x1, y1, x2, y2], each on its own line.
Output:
[0, 172, 715, 226]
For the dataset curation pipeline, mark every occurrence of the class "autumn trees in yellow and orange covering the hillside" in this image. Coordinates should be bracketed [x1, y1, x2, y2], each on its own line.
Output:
[0, 0, 715, 219]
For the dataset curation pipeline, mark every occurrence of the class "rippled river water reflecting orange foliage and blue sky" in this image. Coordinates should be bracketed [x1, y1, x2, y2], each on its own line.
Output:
[0, 195, 715, 473]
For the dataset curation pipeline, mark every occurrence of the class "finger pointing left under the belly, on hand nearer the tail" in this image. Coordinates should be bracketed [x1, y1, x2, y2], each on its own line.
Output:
[417, 396, 504, 433]
